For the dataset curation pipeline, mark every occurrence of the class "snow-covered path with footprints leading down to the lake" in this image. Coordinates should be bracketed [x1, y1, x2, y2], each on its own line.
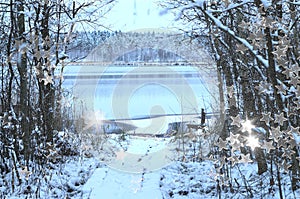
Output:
[82, 136, 171, 199]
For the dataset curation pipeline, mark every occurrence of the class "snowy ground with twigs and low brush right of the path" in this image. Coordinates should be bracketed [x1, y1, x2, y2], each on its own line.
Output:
[160, 160, 300, 199]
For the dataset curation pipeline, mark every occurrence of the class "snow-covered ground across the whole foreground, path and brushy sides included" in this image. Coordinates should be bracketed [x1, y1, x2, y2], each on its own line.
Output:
[5, 134, 300, 199]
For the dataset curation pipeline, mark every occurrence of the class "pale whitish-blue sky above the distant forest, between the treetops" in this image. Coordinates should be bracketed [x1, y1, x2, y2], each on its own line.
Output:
[102, 0, 179, 32]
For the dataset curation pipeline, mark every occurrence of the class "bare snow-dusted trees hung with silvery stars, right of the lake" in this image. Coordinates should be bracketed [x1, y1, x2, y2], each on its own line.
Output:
[162, 0, 300, 190]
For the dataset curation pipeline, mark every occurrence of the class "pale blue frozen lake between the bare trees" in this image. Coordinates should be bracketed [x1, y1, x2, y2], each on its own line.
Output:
[64, 65, 215, 133]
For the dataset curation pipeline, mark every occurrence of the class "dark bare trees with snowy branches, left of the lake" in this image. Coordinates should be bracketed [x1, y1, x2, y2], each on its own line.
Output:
[0, 0, 113, 192]
